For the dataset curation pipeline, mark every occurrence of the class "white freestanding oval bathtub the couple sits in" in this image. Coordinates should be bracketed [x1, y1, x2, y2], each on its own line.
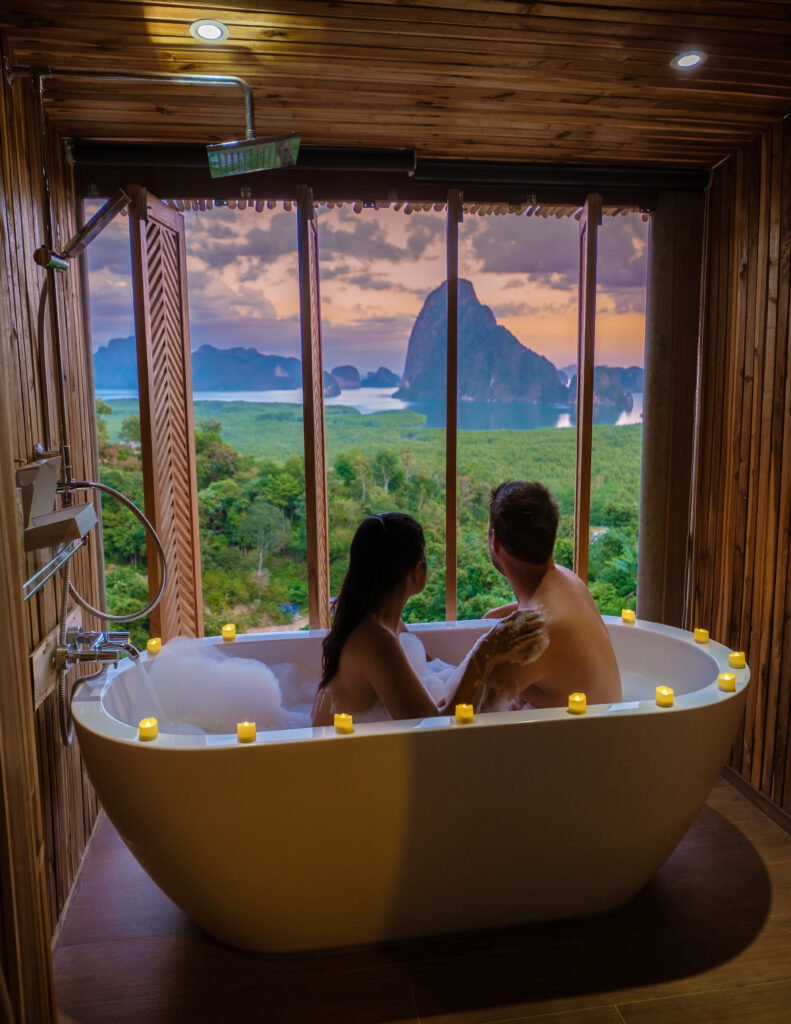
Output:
[73, 618, 749, 951]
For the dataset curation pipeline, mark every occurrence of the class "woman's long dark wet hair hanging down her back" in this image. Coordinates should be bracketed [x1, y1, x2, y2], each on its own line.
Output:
[319, 512, 425, 689]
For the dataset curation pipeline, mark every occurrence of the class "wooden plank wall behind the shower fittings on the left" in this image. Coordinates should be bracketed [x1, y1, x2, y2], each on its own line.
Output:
[0, 58, 99, 958]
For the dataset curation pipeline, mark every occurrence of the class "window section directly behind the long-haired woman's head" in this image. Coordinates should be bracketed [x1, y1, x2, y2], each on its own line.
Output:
[319, 198, 447, 622]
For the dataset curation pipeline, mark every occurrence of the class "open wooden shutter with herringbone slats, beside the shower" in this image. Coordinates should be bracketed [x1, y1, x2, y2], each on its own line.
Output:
[128, 185, 203, 640]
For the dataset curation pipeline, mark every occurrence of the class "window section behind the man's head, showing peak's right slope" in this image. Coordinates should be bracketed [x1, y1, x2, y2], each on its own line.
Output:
[458, 208, 578, 618]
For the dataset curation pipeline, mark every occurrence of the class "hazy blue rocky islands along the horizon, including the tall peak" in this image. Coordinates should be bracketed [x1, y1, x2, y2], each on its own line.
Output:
[93, 279, 644, 411]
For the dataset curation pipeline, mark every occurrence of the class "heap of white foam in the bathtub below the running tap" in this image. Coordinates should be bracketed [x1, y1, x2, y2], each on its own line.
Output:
[129, 639, 318, 734]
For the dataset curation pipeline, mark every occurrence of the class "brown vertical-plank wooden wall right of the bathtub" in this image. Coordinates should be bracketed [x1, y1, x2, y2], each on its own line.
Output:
[688, 119, 791, 811]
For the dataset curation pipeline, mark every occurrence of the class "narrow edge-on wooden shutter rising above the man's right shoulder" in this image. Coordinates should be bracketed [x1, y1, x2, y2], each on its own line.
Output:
[574, 194, 601, 583]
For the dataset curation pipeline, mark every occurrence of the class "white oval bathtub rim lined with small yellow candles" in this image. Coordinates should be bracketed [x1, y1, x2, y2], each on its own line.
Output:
[72, 615, 750, 751]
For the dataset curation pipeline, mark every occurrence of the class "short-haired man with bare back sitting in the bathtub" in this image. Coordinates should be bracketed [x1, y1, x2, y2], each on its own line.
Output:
[440, 480, 622, 714]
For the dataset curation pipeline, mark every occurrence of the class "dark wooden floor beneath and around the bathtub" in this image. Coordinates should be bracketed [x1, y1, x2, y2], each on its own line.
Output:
[54, 780, 791, 1024]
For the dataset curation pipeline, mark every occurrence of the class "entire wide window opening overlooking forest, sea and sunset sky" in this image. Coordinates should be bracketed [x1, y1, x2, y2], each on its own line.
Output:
[88, 188, 647, 626]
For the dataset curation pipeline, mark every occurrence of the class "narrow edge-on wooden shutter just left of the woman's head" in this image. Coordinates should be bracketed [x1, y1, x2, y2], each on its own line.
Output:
[297, 187, 330, 630]
